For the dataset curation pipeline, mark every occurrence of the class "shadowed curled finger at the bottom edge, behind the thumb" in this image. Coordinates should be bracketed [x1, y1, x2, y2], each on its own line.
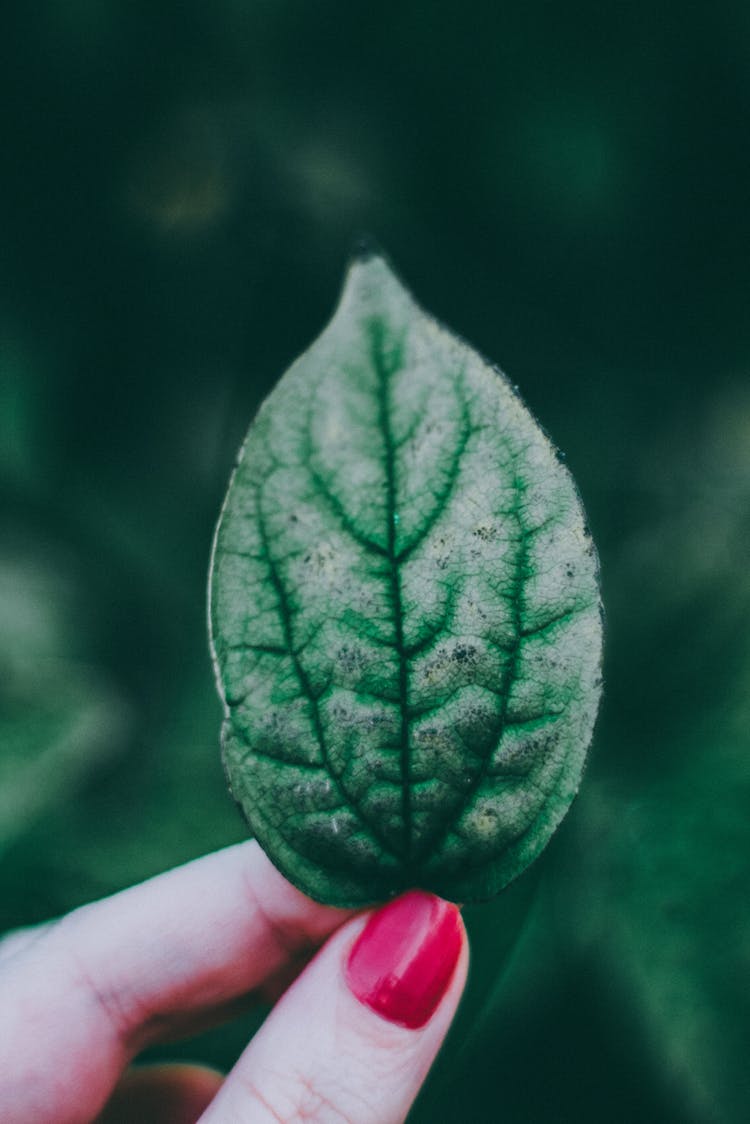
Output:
[97, 1064, 224, 1124]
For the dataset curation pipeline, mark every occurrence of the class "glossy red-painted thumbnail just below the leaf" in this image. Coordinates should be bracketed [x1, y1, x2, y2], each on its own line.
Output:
[346, 890, 462, 1030]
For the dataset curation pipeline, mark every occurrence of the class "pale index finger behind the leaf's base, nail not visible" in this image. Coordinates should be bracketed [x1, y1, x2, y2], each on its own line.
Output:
[0, 843, 347, 1124]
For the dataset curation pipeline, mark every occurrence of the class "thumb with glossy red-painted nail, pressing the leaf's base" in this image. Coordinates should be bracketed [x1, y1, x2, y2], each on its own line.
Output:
[201, 890, 468, 1124]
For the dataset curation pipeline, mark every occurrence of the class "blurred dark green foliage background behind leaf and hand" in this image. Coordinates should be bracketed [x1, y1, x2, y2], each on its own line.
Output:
[0, 0, 750, 1124]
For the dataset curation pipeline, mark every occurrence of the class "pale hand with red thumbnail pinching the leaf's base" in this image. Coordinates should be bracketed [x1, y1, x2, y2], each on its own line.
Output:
[0, 843, 468, 1124]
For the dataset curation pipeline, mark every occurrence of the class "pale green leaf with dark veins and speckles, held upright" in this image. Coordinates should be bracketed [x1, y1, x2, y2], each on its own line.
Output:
[209, 256, 600, 905]
